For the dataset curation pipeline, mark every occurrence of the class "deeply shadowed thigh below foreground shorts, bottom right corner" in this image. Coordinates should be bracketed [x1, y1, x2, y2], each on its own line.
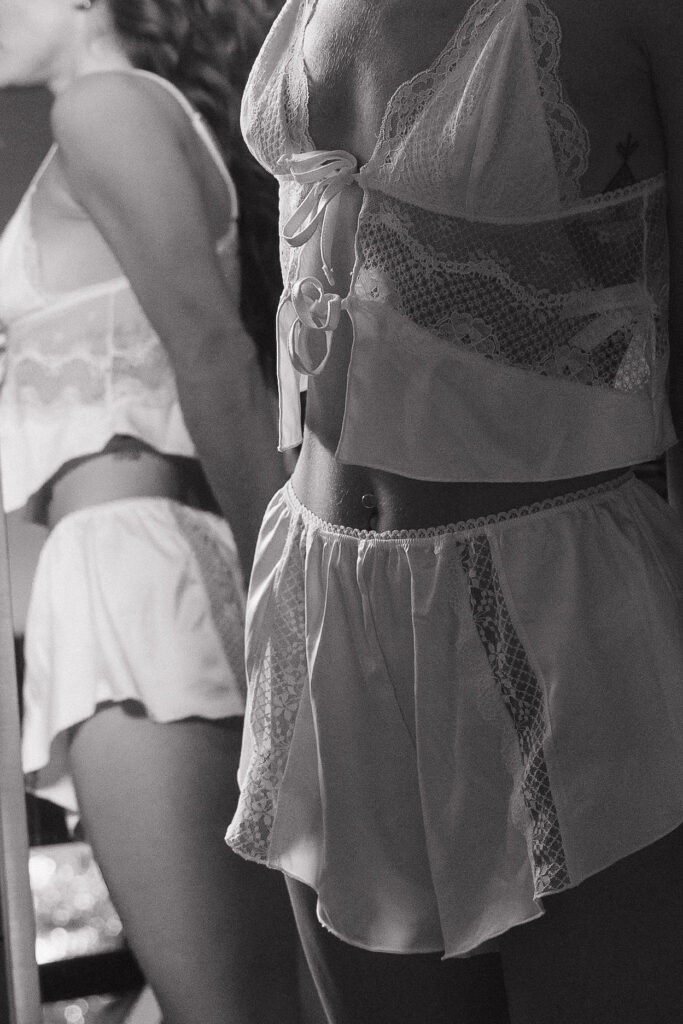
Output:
[502, 828, 683, 1024]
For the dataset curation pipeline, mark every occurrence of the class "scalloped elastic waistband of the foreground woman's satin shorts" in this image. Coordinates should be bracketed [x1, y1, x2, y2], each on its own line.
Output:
[282, 470, 635, 542]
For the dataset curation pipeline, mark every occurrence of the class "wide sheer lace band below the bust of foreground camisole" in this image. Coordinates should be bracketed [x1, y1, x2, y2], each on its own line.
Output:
[354, 182, 667, 391]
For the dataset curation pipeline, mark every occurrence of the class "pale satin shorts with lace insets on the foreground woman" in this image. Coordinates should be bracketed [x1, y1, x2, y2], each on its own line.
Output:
[227, 478, 683, 955]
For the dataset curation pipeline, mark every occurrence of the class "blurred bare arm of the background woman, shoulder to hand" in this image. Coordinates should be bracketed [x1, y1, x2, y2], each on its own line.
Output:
[52, 73, 284, 574]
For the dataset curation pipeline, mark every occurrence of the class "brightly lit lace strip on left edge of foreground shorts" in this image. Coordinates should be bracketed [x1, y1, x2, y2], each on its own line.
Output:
[226, 523, 308, 862]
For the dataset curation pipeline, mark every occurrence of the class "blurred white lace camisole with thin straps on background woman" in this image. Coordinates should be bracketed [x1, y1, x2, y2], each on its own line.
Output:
[0, 69, 240, 511]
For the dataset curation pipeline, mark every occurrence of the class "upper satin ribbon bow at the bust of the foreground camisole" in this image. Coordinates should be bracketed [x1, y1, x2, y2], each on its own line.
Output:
[283, 150, 358, 285]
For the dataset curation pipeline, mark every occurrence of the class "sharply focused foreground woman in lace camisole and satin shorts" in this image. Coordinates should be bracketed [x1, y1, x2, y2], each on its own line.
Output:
[227, 0, 683, 1024]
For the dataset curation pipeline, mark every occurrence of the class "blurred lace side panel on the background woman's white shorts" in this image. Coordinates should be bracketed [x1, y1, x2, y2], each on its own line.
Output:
[170, 502, 247, 698]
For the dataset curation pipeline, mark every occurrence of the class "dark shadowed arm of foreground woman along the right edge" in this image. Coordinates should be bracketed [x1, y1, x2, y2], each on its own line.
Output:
[638, 0, 683, 515]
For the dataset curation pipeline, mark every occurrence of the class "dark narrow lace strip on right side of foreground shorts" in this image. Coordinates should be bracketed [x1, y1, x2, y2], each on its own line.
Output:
[460, 536, 571, 896]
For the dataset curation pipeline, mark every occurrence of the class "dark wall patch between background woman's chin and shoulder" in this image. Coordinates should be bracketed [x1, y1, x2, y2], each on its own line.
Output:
[0, 88, 52, 228]
